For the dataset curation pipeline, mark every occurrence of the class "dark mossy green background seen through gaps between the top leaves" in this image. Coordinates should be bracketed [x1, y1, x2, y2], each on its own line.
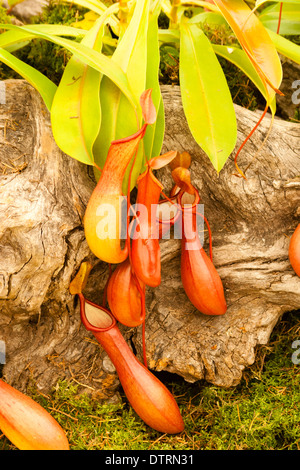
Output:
[0, 0, 264, 110]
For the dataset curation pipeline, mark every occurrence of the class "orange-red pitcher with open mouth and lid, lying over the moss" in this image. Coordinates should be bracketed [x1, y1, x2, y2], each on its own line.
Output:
[70, 263, 184, 434]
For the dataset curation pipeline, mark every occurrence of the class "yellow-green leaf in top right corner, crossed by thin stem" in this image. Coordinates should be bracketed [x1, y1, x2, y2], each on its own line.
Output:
[259, 2, 300, 35]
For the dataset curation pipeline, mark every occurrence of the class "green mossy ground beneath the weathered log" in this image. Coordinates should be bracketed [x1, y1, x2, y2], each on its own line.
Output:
[0, 312, 300, 450]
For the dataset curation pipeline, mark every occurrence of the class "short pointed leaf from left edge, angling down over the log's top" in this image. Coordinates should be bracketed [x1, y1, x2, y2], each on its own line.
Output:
[0, 49, 57, 110]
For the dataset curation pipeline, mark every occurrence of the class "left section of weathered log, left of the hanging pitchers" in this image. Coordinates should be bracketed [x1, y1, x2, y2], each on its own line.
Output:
[0, 80, 122, 397]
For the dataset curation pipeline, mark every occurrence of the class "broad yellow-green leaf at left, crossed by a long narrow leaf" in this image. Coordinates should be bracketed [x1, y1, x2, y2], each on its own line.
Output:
[51, 18, 104, 165]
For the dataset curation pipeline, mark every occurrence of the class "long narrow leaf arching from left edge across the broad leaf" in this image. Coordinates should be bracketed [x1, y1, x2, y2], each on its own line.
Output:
[0, 24, 138, 109]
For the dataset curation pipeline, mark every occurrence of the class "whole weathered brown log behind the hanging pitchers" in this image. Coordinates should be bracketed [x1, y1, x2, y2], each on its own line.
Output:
[0, 80, 300, 398]
